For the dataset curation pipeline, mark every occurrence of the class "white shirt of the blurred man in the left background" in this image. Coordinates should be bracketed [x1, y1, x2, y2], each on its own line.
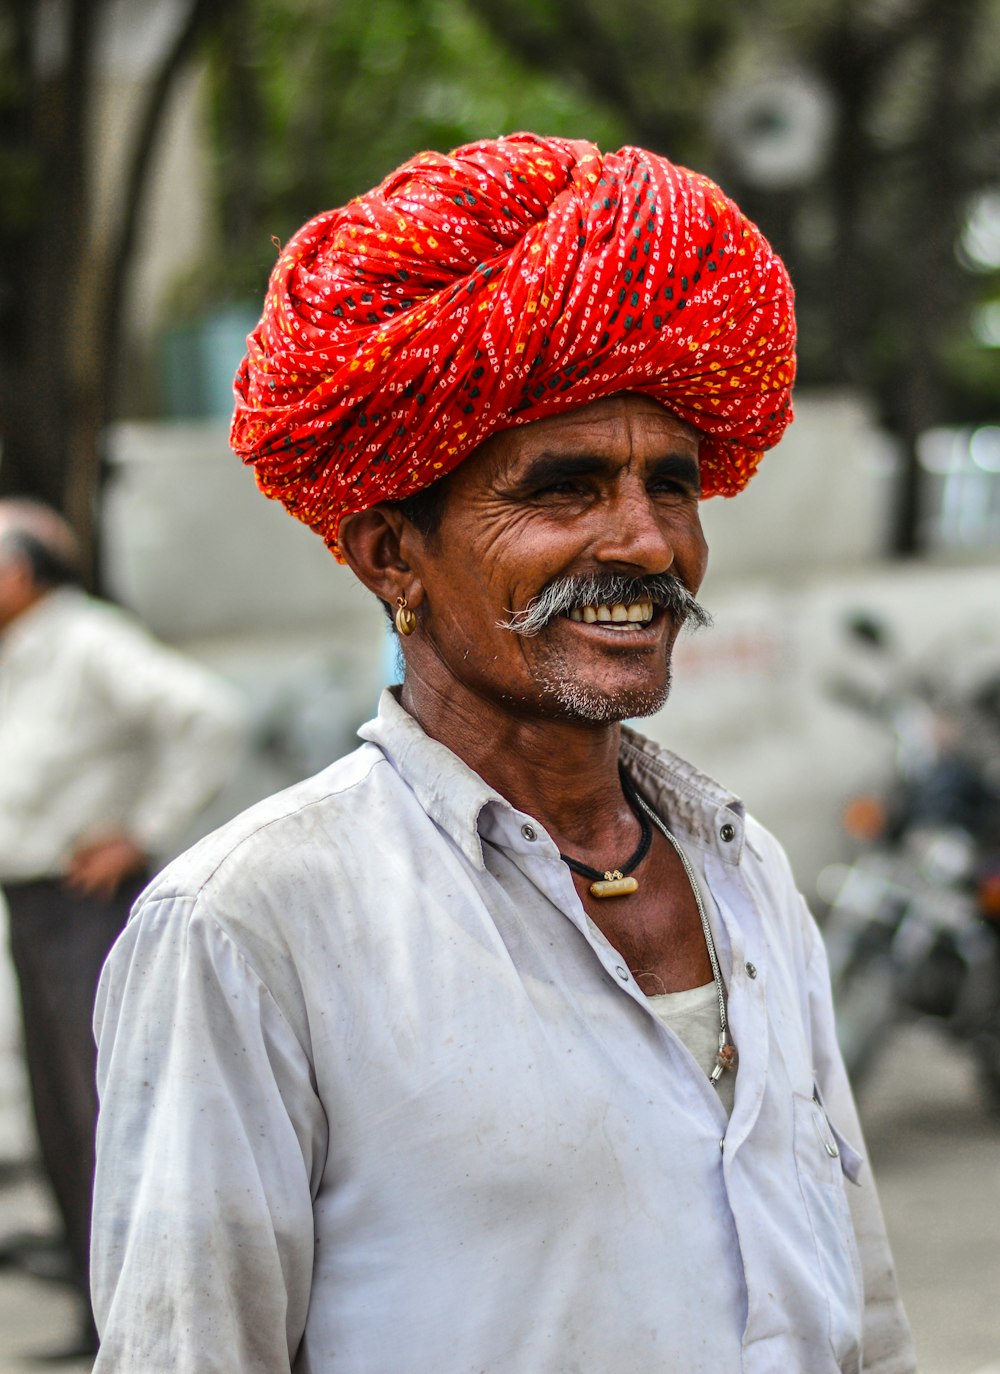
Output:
[0, 588, 243, 882]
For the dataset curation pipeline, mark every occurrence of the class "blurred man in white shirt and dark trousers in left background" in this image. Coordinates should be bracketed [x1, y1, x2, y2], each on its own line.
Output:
[0, 500, 243, 1348]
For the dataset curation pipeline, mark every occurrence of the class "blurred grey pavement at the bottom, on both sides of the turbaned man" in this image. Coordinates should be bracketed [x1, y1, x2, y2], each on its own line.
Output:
[0, 1026, 1000, 1374]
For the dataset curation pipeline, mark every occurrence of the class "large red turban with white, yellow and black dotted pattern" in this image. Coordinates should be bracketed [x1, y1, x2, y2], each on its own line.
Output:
[231, 133, 795, 556]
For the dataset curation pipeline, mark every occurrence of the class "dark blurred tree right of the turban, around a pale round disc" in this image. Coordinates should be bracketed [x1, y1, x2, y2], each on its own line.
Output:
[468, 0, 1000, 554]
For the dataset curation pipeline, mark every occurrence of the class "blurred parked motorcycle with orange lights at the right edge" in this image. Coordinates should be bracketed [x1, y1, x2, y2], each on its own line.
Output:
[819, 617, 1000, 1112]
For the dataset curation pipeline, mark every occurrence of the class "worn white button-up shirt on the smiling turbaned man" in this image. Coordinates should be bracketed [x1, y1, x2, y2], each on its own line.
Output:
[93, 694, 915, 1374]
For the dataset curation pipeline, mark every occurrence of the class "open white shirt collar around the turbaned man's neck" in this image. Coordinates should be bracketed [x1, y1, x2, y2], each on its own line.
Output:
[359, 687, 745, 868]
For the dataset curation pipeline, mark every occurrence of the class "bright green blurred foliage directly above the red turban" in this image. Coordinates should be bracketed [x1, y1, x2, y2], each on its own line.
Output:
[184, 0, 626, 315]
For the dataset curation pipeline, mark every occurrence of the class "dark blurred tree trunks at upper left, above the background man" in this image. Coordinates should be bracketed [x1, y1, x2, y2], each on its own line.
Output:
[0, 0, 238, 583]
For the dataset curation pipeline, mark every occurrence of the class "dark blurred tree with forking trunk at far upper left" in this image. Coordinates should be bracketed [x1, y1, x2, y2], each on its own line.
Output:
[0, 0, 239, 577]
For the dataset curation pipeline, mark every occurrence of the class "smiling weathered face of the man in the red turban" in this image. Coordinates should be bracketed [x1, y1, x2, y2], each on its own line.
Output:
[401, 393, 707, 723]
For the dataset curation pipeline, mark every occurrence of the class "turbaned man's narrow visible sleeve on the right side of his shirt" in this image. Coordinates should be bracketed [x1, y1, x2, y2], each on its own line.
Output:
[808, 916, 916, 1374]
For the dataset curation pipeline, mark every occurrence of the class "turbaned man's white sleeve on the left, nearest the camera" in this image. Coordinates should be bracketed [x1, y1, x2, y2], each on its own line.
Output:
[92, 897, 326, 1374]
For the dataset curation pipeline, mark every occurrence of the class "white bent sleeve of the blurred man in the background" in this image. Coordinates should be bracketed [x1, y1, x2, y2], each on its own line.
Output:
[84, 617, 246, 855]
